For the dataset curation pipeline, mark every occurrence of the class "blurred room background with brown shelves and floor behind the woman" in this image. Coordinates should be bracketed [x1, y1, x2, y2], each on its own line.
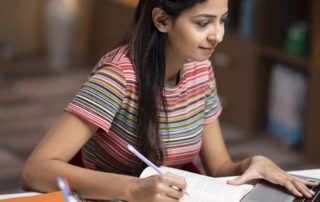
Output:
[0, 0, 320, 194]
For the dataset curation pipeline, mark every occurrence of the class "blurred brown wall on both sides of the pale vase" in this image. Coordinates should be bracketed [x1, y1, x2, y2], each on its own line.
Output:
[0, 0, 95, 59]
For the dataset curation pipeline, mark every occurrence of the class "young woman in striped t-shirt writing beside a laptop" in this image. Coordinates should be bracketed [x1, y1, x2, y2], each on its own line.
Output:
[21, 0, 318, 202]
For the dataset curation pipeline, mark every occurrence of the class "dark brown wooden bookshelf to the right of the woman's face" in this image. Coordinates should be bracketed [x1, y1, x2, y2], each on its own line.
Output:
[213, 0, 320, 163]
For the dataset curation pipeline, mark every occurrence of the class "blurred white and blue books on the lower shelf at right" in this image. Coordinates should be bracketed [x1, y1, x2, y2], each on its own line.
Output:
[268, 64, 307, 147]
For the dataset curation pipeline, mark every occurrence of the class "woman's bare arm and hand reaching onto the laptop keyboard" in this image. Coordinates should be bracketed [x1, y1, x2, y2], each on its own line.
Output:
[200, 120, 315, 197]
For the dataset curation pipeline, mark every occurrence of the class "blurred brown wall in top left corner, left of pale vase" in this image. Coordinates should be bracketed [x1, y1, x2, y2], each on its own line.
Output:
[0, 0, 43, 54]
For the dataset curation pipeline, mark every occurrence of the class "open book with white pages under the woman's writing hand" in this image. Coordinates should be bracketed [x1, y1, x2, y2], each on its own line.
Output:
[140, 167, 253, 202]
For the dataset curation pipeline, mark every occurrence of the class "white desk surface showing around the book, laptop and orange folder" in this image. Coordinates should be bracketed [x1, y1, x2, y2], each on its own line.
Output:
[0, 168, 320, 199]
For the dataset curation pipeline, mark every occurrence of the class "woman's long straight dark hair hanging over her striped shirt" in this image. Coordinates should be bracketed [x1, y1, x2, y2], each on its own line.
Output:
[129, 0, 205, 174]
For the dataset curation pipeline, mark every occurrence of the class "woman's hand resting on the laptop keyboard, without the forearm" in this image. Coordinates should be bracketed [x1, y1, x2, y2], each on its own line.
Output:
[227, 156, 318, 198]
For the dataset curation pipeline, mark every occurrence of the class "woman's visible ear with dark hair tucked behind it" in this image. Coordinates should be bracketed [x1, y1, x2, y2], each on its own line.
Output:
[152, 7, 171, 33]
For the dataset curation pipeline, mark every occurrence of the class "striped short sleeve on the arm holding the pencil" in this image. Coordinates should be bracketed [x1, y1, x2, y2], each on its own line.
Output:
[65, 65, 126, 132]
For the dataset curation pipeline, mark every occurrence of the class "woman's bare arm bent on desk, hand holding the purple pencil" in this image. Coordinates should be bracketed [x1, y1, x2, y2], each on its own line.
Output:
[21, 112, 186, 201]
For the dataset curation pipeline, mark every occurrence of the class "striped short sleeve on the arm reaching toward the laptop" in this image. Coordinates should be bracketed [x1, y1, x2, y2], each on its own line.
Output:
[203, 64, 222, 124]
